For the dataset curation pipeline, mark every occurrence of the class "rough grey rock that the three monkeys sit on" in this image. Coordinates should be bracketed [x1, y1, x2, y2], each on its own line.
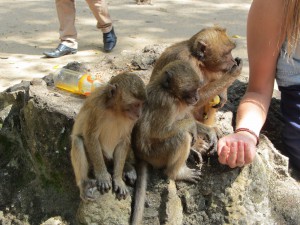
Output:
[0, 46, 300, 225]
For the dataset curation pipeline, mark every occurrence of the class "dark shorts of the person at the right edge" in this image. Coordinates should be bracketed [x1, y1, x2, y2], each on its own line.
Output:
[279, 85, 300, 170]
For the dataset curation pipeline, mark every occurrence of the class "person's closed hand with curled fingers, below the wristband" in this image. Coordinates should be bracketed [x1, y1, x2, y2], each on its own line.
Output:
[218, 131, 256, 168]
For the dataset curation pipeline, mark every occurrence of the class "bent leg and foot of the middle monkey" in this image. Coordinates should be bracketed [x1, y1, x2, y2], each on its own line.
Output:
[165, 133, 201, 183]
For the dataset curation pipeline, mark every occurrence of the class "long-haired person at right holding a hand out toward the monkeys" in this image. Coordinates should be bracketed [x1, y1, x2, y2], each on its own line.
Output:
[218, 0, 300, 170]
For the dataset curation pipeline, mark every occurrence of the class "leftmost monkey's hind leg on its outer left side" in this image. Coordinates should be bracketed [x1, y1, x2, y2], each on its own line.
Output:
[71, 135, 96, 201]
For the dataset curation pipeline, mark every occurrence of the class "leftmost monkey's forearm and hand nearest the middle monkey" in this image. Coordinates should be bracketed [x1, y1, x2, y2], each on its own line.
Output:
[113, 142, 130, 200]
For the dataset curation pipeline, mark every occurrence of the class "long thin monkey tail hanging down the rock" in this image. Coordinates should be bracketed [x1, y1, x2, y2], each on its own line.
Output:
[131, 161, 148, 225]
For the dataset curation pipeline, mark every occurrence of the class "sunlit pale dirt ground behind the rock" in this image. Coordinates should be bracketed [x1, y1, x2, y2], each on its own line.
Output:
[0, 0, 251, 92]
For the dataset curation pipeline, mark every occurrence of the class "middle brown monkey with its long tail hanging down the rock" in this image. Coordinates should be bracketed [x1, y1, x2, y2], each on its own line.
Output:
[132, 60, 204, 225]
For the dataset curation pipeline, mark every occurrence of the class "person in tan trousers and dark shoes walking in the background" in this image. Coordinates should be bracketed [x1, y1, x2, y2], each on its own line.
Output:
[43, 0, 117, 58]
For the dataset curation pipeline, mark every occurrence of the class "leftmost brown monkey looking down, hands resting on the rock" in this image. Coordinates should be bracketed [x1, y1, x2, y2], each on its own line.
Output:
[71, 73, 146, 201]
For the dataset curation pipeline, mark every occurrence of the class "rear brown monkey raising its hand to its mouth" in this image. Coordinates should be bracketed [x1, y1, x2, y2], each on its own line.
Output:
[150, 26, 242, 125]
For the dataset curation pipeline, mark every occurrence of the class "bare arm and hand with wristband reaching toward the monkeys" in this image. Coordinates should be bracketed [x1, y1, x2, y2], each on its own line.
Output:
[218, 0, 285, 168]
